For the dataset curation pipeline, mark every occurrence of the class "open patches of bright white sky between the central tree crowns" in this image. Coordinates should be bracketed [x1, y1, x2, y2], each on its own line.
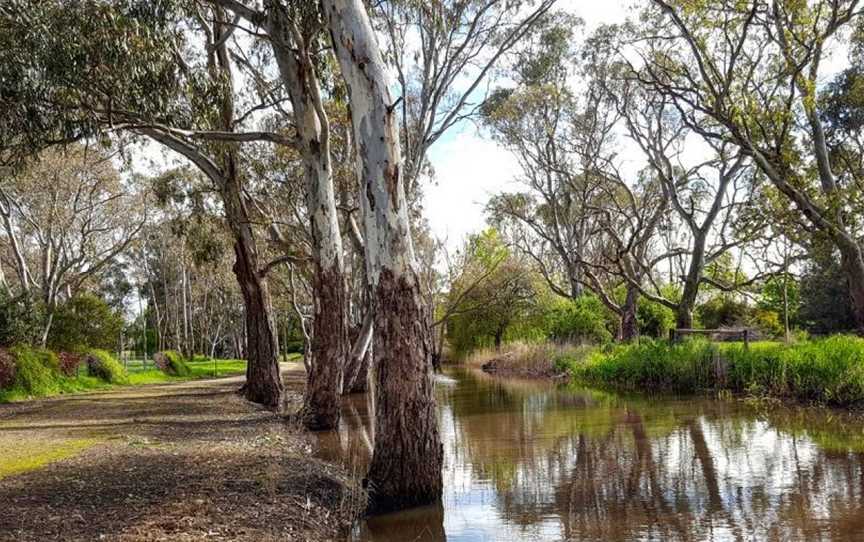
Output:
[424, 0, 633, 250]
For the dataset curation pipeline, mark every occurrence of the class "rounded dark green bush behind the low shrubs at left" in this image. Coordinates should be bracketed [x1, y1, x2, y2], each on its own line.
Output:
[48, 294, 123, 351]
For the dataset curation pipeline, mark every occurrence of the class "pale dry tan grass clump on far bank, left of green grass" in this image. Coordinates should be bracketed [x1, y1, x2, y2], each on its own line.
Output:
[465, 342, 591, 378]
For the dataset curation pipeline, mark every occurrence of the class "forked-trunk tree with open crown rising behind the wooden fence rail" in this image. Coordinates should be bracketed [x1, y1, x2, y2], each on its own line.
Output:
[618, 89, 764, 328]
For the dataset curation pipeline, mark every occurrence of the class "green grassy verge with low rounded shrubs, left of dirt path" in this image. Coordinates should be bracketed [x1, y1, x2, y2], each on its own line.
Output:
[0, 345, 246, 403]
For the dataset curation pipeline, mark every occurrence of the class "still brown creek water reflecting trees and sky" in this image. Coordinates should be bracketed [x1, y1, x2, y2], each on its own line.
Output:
[320, 371, 864, 542]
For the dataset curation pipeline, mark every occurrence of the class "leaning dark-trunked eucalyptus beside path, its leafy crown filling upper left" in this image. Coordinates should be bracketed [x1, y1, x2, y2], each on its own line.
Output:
[0, 0, 287, 405]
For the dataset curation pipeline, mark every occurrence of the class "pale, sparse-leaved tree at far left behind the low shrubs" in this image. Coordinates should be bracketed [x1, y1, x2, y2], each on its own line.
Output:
[0, 144, 147, 345]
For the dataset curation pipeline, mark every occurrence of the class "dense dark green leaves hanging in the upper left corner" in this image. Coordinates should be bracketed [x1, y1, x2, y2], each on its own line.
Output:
[0, 0, 183, 166]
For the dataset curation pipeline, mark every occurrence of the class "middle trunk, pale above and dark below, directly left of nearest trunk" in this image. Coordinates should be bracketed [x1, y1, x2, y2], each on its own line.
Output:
[268, 4, 349, 429]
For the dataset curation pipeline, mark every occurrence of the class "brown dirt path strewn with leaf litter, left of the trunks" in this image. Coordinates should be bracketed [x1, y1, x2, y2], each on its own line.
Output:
[0, 365, 357, 541]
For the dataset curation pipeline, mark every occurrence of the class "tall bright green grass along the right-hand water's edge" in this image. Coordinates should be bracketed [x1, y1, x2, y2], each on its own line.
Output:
[568, 336, 864, 406]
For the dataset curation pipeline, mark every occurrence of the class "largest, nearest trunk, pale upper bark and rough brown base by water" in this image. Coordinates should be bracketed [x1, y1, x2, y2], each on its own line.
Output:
[322, 0, 443, 512]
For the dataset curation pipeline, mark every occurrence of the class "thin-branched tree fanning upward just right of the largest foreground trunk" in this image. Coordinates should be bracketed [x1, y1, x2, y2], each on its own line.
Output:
[372, 0, 555, 200]
